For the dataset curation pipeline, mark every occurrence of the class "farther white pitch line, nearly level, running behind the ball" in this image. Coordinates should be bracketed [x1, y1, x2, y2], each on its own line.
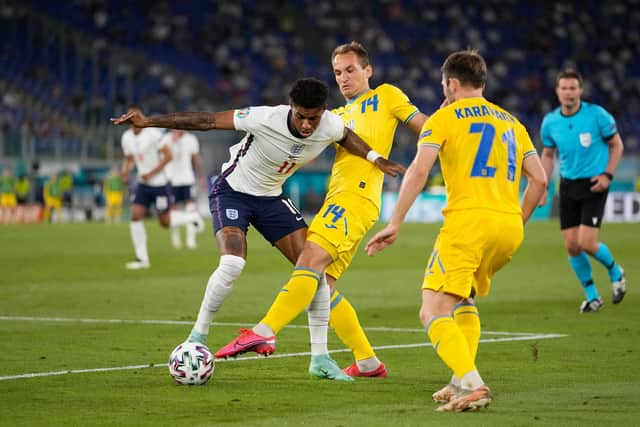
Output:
[0, 316, 535, 336]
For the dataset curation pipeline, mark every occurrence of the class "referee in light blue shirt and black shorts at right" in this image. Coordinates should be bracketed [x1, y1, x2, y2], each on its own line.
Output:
[540, 70, 627, 313]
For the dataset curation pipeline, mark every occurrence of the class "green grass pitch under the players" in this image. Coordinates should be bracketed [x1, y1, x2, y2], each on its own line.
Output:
[0, 222, 640, 426]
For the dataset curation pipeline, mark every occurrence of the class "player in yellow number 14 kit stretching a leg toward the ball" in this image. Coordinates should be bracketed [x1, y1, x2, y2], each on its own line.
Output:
[216, 42, 427, 379]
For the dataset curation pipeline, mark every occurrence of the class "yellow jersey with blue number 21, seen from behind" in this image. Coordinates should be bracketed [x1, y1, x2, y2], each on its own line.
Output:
[418, 97, 536, 215]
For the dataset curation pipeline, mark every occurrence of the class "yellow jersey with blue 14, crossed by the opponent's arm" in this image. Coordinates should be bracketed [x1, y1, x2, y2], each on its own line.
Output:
[327, 84, 419, 209]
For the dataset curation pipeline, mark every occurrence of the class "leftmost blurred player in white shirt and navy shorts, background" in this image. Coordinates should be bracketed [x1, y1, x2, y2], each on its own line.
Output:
[122, 126, 202, 270]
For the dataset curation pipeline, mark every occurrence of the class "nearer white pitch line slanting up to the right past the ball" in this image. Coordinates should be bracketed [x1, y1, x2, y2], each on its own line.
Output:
[0, 334, 567, 381]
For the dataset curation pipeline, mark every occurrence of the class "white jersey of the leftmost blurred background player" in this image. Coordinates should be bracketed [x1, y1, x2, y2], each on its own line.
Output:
[122, 128, 169, 187]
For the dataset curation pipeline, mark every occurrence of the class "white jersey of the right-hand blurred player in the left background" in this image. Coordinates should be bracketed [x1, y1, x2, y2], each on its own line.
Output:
[162, 132, 200, 186]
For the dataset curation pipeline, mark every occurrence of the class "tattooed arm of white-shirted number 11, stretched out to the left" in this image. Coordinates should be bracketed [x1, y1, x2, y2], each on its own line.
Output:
[111, 108, 235, 130]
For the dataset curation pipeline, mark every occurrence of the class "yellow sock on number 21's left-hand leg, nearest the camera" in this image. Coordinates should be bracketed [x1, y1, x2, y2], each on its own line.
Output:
[427, 316, 476, 378]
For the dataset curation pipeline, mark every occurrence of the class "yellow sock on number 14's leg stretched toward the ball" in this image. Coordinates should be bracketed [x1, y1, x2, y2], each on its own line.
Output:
[260, 267, 320, 335]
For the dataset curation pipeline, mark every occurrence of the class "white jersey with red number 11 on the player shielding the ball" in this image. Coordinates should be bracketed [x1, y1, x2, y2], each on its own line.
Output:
[222, 105, 344, 196]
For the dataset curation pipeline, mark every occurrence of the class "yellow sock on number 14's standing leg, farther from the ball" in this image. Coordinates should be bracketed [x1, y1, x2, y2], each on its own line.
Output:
[329, 289, 376, 360]
